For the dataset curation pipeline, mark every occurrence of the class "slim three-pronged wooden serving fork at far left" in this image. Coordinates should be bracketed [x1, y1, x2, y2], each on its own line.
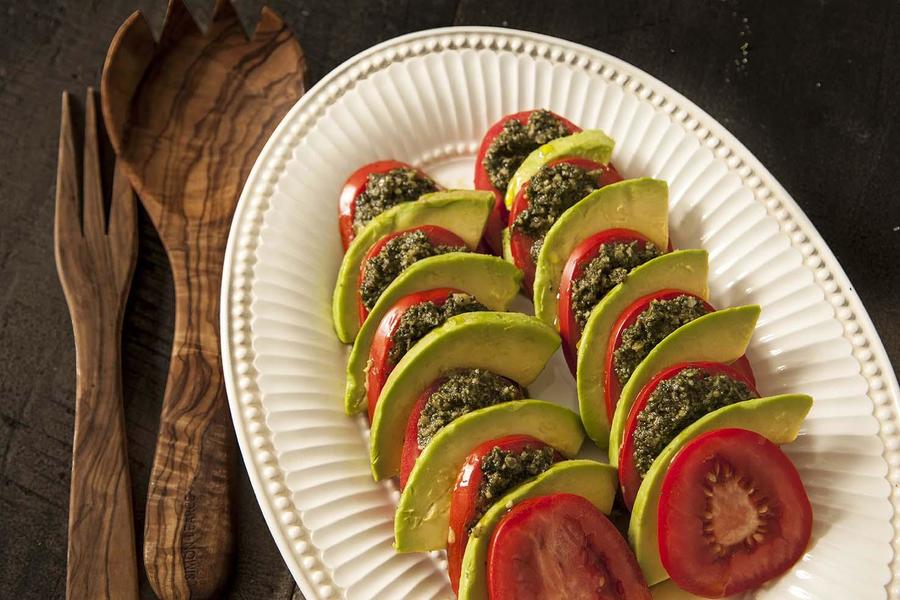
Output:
[54, 89, 138, 600]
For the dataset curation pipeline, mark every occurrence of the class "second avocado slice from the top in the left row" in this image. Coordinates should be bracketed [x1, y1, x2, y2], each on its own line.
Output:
[344, 252, 522, 415]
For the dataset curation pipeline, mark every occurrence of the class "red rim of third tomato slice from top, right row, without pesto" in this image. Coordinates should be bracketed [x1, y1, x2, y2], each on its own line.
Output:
[559, 229, 650, 375]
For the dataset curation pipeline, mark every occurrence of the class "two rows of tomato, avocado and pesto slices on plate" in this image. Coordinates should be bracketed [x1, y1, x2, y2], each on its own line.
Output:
[333, 110, 812, 600]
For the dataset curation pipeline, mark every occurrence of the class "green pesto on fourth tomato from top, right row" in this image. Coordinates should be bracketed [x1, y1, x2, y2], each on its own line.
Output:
[613, 294, 709, 385]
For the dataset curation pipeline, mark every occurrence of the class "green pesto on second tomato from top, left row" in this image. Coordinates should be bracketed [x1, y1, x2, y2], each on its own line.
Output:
[359, 231, 469, 310]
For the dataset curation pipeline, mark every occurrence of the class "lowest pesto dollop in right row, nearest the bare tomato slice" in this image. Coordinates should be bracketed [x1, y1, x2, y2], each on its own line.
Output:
[633, 369, 756, 477]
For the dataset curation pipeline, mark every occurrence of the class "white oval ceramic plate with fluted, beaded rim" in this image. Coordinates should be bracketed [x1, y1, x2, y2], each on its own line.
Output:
[221, 27, 900, 600]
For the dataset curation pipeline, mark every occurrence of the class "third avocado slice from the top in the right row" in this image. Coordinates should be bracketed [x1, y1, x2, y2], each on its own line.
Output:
[576, 250, 709, 448]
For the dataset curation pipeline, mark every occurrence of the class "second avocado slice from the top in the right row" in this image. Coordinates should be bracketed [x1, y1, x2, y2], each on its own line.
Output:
[534, 178, 669, 327]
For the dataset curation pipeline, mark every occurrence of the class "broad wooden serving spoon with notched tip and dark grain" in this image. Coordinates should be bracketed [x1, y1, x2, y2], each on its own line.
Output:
[101, 0, 306, 599]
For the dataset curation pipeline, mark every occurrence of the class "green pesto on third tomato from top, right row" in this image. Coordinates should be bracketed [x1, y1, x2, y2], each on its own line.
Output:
[572, 241, 661, 329]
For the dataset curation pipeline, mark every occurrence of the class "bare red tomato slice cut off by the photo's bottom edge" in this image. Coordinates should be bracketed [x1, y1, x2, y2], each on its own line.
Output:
[487, 494, 651, 600]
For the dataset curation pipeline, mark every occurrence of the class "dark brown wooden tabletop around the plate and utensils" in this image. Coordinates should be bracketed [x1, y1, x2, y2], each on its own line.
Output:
[0, 0, 900, 600]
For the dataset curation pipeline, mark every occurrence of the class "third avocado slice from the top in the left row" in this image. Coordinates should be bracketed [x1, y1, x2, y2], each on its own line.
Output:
[371, 312, 559, 481]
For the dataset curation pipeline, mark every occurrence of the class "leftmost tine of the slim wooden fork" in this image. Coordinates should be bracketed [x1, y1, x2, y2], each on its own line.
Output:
[53, 92, 81, 241]
